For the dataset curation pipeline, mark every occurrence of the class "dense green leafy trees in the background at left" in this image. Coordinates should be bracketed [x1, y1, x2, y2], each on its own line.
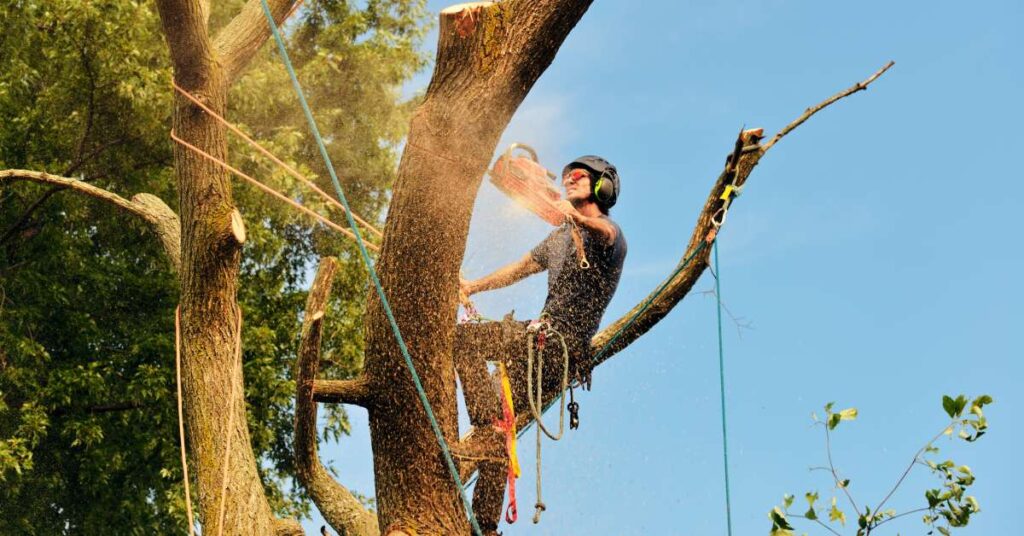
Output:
[0, 0, 426, 534]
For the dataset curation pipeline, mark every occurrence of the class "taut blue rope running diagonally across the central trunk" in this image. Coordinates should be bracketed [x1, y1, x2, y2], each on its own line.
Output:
[253, 0, 483, 536]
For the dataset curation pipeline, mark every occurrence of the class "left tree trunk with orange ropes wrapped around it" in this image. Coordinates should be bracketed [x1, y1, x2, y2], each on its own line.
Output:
[157, 0, 292, 534]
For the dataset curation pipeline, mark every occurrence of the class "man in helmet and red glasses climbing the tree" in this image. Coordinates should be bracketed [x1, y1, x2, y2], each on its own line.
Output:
[456, 156, 627, 533]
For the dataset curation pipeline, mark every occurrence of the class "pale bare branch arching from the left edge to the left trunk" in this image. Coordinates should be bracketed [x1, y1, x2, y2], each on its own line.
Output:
[0, 169, 181, 271]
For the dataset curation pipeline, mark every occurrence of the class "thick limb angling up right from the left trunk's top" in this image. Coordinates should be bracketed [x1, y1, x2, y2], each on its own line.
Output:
[213, 0, 302, 85]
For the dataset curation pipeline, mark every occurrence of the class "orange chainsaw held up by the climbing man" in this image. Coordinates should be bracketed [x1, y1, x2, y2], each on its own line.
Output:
[487, 143, 565, 226]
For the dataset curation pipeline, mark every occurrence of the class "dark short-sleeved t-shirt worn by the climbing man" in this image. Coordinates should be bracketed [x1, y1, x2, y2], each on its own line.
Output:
[530, 216, 626, 357]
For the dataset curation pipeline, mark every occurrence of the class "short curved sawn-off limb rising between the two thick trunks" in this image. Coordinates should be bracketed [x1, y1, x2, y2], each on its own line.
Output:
[295, 257, 380, 536]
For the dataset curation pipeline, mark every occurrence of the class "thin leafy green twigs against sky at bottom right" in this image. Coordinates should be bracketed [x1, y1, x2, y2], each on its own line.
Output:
[768, 395, 992, 536]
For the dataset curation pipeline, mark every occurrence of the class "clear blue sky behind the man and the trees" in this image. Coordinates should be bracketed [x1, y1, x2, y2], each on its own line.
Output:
[305, 0, 1024, 536]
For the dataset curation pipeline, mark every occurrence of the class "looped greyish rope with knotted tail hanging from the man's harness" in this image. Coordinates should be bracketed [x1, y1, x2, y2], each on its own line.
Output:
[526, 314, 569, 524]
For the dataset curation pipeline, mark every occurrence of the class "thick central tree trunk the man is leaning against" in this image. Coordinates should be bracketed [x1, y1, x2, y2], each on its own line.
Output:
[366, 0, 590, 534]
